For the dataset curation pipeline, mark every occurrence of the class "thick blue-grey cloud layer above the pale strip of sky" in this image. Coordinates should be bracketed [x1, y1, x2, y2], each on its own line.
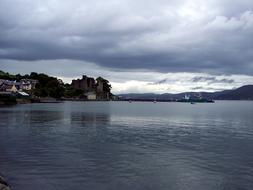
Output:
[0, 0, 253, 75]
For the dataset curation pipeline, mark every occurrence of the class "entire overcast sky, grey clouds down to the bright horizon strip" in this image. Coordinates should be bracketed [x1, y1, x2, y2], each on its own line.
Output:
[0, 0, 253, 93]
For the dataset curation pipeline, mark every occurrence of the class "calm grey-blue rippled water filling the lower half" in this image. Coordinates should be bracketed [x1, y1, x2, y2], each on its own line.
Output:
[0, 101, 253, 190]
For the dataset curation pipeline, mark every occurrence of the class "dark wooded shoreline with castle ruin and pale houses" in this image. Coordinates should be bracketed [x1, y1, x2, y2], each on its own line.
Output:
[0, 71, 117, 104]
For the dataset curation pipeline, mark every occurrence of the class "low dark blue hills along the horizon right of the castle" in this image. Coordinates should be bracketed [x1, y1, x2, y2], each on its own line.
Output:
[118, 85, 253, 100]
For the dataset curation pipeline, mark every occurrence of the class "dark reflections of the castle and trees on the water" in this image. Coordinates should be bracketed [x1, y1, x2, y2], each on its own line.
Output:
[0, 110, 110, 127]
